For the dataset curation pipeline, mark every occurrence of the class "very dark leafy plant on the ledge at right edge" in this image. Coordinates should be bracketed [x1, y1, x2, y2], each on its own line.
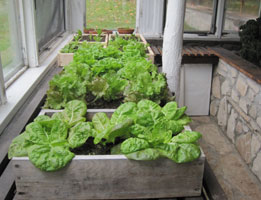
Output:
[239, 18, 261, 67]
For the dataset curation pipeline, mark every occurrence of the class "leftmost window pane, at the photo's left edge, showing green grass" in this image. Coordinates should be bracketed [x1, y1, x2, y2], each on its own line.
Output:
[0, 0, 23, 80]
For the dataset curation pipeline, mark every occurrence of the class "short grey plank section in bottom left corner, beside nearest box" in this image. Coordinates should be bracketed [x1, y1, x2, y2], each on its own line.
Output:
[0, 162, 15, 199]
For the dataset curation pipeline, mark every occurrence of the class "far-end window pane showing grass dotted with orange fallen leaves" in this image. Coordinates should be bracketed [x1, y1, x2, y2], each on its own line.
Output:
[86, 0, 136, 29]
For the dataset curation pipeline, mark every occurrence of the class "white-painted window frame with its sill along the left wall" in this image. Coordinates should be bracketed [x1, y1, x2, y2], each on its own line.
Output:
[0, 0, 85, 135]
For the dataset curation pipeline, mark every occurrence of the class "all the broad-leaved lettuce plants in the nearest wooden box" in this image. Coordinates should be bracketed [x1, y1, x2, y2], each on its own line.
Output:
[8, 100, 201, 171]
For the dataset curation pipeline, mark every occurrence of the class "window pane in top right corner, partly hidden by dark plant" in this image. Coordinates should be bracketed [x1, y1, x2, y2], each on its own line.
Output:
[224, 0, 260, 31]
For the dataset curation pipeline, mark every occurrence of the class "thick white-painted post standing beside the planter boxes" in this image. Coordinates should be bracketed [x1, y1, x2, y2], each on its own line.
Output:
[162, 0, 186, 100]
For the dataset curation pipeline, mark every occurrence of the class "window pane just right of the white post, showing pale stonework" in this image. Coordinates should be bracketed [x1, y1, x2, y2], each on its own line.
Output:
[184, 0, 213, 32]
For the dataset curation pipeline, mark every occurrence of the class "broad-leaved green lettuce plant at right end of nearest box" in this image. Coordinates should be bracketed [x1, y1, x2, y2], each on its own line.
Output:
[111, 100, 201, 163]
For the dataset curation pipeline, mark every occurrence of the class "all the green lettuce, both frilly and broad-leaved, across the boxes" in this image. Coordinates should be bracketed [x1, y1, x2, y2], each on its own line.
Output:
[8, 34, 201, 171]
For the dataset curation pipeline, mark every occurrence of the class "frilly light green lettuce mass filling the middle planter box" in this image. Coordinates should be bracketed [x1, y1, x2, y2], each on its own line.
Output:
[45, 32, 169, 109]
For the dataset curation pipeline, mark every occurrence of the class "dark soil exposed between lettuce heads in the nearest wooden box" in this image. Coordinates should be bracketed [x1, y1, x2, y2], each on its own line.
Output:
[71, 138, 123, 155]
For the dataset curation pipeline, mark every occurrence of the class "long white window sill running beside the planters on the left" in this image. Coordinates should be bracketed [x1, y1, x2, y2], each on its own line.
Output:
[0, 35, 72, 135]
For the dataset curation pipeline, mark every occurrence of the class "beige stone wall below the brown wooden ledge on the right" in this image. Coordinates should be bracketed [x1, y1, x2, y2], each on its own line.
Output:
[210, 59, 261, 181]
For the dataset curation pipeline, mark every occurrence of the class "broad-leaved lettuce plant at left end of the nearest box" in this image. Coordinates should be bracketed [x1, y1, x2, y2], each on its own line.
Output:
[8, 100, 93, 171]
